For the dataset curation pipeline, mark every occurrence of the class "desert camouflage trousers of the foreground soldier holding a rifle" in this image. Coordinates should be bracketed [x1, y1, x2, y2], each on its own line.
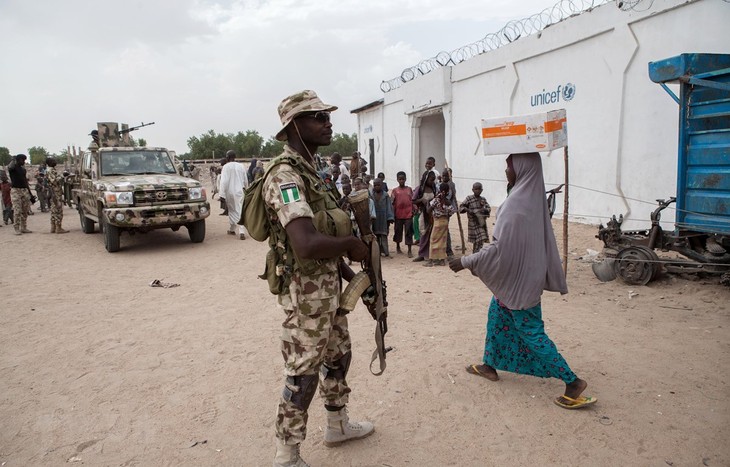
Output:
[276, 273, 351, 444]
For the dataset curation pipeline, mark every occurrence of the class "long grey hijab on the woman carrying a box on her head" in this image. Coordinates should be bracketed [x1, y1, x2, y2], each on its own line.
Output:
[461, 153, 568, 310]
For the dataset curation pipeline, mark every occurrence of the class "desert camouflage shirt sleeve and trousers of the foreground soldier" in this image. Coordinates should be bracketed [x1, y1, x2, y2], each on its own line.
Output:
[263, 146, 351, 445]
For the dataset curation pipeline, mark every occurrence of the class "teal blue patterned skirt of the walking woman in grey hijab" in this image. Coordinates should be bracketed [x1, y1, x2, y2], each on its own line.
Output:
[484, 297, 577, 384]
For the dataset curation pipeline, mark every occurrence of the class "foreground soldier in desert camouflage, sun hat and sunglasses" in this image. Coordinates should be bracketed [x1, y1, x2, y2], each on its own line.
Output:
[262, 91, 374, 467]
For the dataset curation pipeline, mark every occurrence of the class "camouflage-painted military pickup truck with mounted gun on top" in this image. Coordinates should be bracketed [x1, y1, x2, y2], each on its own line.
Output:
[70, 122, 210, 253]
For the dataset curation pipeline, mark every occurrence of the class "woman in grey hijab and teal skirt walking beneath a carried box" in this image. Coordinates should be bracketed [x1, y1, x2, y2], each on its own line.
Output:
[449, 153, 596, 409]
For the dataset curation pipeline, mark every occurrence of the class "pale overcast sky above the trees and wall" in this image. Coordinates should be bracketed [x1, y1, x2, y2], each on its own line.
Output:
[0, 0, 558, 154]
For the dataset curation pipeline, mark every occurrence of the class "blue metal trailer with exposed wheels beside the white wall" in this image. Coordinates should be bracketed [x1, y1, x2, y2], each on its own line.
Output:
[594, 54, 730, 284]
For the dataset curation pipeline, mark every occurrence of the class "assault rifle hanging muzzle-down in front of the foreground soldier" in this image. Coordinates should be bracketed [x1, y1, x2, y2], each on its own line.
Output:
[340, 190, 393, 376]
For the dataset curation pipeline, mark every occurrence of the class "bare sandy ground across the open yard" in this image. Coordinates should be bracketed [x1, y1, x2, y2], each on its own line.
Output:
[0, 191, 730, 467]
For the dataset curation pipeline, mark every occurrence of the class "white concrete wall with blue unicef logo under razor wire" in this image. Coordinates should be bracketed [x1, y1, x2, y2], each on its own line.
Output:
[358, 0, 730, 228]
